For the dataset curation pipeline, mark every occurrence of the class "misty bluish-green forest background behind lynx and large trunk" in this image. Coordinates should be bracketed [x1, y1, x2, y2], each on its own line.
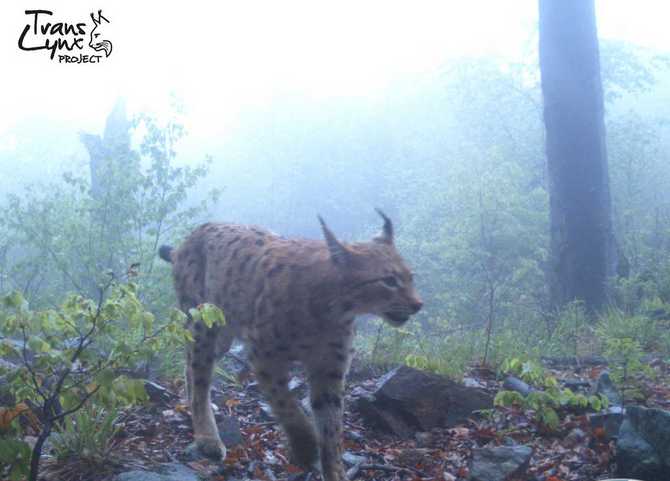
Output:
[5, 34, 670, 374]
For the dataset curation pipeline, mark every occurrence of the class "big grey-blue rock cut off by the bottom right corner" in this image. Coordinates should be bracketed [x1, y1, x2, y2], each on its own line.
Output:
[616, 406, 670, 481]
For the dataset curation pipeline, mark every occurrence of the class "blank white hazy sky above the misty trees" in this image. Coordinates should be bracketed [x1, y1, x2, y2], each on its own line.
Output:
[0, 0, 670, 148]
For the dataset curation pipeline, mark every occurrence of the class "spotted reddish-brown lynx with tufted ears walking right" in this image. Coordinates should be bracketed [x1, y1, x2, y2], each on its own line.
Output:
[159, 210, 422, 481]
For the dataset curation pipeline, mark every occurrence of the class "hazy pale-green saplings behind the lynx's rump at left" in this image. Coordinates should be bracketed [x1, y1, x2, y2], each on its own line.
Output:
[0, 109, 218, 319]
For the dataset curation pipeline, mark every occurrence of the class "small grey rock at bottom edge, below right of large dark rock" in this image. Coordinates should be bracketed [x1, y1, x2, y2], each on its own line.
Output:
[470, 446, 533, 481]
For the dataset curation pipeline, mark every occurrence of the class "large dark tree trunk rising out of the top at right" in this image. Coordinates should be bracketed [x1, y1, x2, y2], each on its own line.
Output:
[539, 0, 617, 312]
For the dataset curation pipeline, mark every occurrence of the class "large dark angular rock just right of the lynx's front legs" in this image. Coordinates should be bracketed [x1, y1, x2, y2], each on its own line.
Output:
[356, 366, 493, 438]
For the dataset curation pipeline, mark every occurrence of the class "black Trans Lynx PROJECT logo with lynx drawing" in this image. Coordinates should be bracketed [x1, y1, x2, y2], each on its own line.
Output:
[19, 10, 112, 64]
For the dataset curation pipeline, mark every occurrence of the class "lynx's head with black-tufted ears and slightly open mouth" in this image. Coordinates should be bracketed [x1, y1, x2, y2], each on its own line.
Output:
[319, 209, 423, 327]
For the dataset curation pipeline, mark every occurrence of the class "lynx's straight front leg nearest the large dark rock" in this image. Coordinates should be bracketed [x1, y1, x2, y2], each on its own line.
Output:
[308, 339, 351, 481]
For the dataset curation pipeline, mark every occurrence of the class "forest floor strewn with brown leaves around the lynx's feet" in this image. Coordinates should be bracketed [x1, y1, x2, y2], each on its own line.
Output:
[40, 354, 670, 481]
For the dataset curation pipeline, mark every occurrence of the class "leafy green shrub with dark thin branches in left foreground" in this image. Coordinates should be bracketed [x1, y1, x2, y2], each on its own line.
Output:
[0, 280, 192, 479]
